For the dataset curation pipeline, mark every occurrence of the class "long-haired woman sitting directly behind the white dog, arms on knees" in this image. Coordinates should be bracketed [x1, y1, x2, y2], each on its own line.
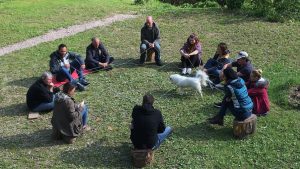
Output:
[180, 33, 202, 75]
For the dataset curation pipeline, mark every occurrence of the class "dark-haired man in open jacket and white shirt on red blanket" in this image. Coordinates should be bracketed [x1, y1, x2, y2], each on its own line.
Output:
[50, 44, 89, 90]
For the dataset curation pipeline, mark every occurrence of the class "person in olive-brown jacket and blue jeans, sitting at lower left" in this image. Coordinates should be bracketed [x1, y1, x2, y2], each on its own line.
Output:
[51, 82, 89, 144]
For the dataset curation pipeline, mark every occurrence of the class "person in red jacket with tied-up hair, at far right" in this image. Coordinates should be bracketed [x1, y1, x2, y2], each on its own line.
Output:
[247, 69, 270, 115]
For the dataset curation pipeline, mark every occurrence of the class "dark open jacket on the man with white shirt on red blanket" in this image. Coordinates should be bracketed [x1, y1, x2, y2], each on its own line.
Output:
[49, 51, 83, 74]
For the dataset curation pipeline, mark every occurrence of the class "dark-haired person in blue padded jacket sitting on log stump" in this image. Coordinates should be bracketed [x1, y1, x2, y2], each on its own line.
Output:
[208, 68, 253, 125]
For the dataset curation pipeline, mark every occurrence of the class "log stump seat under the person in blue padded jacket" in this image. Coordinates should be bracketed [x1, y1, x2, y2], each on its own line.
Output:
[233, 114, 257, 139]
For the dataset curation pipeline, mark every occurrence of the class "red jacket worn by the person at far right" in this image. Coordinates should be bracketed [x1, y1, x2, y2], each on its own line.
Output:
[247, 78, 270, 114]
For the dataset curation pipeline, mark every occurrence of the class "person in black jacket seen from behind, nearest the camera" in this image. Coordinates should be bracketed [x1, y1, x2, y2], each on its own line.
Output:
[130, 94, 172, 150]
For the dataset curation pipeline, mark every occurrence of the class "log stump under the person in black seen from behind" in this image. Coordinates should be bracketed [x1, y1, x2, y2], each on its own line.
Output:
[131, 149, 154, 168]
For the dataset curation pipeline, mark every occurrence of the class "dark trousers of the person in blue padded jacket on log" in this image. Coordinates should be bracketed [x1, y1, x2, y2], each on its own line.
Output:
[219, 100, 252, 121]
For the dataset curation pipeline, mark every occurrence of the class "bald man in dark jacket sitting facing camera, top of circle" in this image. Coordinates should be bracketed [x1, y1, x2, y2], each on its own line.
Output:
[140, 16, 162, 66]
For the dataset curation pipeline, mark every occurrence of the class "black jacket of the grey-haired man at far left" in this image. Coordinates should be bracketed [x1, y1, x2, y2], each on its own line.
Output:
[26, 79, 53, 110]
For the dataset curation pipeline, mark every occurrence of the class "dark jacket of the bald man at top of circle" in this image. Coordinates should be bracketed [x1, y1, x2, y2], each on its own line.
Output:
[141, 22, 160, 45]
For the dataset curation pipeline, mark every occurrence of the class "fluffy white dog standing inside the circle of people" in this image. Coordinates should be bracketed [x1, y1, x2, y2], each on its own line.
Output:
[170, 70, 209, 97]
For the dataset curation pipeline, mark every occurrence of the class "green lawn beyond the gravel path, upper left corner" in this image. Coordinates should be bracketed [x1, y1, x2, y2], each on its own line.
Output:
[0, 0, 138, 47]
